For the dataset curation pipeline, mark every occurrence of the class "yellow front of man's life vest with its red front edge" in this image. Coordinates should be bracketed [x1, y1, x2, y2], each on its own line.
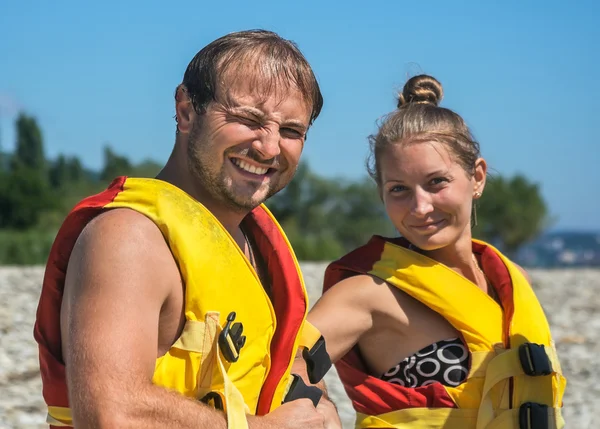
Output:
[48, 178, 320, 429]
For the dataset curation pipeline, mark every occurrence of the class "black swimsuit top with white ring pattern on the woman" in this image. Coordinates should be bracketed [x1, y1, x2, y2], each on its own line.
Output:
[381, 338, 469, 387]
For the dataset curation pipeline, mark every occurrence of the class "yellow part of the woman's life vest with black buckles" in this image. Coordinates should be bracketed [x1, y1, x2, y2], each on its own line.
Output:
[325, 237, 566, 429]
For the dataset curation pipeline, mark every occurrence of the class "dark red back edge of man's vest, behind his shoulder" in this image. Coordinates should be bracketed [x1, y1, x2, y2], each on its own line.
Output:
[33, 177, 127, 407]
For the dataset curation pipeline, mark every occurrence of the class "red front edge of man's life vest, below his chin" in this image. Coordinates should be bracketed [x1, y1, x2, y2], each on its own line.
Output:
[243, 207, 307, 415]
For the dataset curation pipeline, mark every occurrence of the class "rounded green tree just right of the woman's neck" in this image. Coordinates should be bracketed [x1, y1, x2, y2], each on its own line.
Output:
[473, 174, 550, 255]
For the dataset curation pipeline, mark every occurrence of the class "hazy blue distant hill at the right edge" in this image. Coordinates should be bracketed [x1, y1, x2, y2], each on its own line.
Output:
[515, 231, 600, 268]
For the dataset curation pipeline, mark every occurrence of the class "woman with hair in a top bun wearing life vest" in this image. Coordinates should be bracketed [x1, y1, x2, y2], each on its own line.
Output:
[308, 75, 566, 429]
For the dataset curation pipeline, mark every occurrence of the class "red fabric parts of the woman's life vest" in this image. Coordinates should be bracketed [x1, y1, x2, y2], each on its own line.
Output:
[323, 236, 514, 415]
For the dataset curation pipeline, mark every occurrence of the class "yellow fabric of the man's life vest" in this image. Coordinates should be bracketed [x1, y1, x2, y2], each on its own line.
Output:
[49, 178, 308, 429]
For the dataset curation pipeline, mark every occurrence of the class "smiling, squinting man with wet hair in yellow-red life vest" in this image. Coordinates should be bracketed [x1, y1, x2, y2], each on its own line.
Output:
[34, 31, 339, 429]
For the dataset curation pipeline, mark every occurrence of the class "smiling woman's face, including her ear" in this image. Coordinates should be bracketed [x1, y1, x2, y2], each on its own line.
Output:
[379, 142, 486, 251]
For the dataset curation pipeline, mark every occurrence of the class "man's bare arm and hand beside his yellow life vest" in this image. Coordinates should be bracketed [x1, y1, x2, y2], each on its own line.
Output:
[61, 210, 323, 429]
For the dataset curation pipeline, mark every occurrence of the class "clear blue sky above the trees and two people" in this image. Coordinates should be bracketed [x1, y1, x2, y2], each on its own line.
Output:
[0, 0, 600, 230]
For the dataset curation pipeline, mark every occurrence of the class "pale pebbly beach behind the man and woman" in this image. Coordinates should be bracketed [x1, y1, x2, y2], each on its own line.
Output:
[0, 263, 600, 429]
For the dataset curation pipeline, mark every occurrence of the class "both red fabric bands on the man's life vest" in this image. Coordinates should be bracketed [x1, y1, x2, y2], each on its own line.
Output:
[34, 177, 307, 418]
